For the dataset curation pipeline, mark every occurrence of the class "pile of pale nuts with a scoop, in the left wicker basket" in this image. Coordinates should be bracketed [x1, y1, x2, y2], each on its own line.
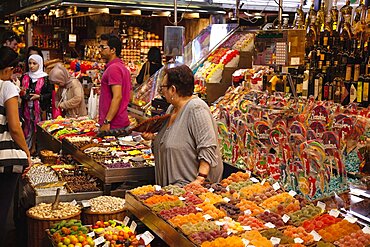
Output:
[28, 202, 80, 219]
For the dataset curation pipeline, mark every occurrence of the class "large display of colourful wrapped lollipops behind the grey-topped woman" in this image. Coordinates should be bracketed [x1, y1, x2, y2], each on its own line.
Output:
[213, 87, 368, 200]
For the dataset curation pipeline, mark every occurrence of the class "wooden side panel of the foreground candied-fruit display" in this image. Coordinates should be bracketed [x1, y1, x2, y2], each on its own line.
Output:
[125, 192, 197, 247]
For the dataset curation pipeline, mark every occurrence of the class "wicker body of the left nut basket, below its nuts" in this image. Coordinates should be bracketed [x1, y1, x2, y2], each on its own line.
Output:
[27, 211, 81, 247]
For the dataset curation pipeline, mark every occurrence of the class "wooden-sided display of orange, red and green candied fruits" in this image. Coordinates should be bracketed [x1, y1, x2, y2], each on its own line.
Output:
[126, 172, 370, 247]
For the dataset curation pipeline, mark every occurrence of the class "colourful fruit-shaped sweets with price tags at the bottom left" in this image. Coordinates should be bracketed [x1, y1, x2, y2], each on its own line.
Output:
[47, 219, 154, 247]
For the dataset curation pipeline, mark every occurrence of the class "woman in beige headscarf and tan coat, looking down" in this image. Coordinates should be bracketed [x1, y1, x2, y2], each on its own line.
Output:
[49, 63, 87, 117]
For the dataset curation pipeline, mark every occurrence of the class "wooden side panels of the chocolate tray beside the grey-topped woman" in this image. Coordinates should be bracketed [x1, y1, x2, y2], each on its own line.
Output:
[62, 139, 155, 184]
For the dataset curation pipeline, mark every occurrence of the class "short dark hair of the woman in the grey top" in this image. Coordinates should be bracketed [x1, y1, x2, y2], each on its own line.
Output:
[164, 64, 194, 97]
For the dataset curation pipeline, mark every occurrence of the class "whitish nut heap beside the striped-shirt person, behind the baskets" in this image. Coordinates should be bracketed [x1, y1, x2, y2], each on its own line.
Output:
[27, 165, 58, 186]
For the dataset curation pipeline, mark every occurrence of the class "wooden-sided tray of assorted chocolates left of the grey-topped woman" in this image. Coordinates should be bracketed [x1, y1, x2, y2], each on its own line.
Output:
[62, 133, 154, 184]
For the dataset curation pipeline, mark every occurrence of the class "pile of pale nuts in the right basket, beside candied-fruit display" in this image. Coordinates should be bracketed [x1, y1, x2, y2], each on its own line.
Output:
[89, 196, 125, 213]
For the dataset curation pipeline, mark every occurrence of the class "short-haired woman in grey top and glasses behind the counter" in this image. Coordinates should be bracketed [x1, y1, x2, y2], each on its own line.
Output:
[143, 65, 223, 186]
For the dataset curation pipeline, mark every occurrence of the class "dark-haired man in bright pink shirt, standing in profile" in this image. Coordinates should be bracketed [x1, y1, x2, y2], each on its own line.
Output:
[99, 34, 132, 131]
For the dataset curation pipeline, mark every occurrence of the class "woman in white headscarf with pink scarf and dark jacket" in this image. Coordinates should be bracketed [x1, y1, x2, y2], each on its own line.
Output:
[20, 54, 53, 154]
